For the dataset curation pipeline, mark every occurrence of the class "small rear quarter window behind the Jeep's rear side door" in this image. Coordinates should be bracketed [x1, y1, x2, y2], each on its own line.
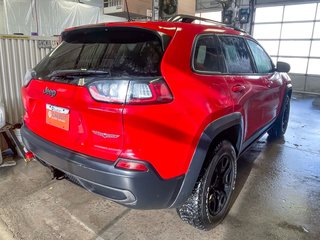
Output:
[193, 35, 223, 72]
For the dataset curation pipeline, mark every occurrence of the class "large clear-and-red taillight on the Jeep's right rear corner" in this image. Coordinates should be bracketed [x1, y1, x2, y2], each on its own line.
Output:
[88, 78, 173, 104]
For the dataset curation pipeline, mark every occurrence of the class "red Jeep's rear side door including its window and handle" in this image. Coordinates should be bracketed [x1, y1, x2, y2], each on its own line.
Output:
[219, 35, 270, 141]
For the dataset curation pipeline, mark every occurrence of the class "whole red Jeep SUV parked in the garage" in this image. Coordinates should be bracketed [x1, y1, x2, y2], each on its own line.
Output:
[22, 16, 292, 229]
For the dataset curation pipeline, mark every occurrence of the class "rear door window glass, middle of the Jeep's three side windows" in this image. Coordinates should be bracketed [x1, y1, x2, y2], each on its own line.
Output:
[220, 37, 253, 73]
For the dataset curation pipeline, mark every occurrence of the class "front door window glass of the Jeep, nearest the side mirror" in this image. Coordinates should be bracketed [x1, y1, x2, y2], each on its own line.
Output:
[248, 40, 273, 73]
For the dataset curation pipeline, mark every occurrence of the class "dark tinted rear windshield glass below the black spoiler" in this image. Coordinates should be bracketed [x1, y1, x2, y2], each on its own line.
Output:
[35, 41, 162, 79]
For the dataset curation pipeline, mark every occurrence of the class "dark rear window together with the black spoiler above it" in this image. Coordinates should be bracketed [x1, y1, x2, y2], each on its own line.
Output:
[34, 27, 164, 80]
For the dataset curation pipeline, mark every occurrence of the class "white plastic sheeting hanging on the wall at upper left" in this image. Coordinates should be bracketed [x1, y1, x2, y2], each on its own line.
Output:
[2, 0, 125, 36]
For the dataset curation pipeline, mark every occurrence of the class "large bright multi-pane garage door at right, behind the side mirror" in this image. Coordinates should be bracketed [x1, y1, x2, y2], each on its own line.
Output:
[253, 0, 320, 94]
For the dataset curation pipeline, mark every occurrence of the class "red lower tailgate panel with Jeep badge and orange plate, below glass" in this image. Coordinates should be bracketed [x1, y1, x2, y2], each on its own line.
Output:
[23, 80, 123, 161]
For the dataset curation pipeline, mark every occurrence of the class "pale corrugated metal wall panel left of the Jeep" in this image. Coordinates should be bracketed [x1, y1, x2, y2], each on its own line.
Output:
[0, 35, 58, 124]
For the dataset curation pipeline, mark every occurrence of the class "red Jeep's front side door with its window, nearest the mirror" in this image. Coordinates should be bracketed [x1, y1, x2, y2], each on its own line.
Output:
[246, 39, 282, 125]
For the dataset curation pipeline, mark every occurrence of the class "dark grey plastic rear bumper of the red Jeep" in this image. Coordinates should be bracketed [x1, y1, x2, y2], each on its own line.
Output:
[21, 125, 184, 209]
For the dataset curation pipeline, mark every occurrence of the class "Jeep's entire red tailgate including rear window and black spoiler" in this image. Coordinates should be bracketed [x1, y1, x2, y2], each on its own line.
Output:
[22, 27, 168, 161]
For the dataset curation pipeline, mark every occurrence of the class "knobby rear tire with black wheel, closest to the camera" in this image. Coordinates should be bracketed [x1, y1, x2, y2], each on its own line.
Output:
[177, 141, 237, 230]
